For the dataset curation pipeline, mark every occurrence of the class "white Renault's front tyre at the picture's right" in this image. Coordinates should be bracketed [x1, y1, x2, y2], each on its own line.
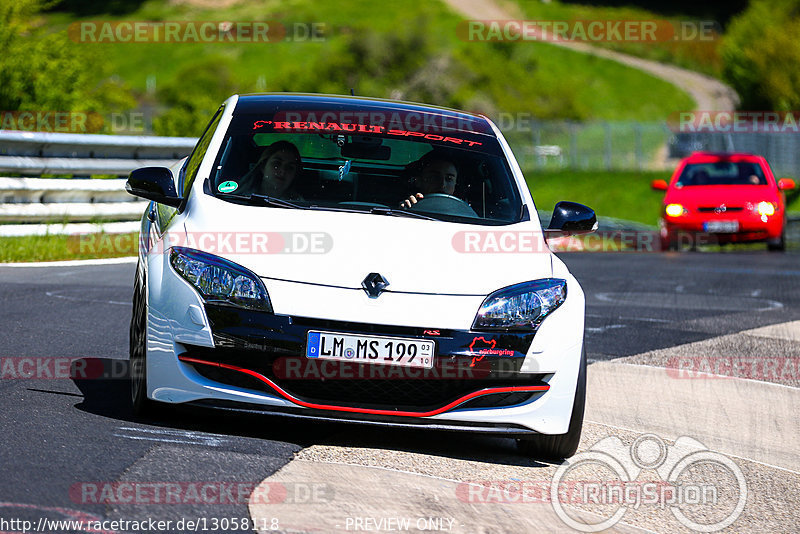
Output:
[517, 349, 586, 460]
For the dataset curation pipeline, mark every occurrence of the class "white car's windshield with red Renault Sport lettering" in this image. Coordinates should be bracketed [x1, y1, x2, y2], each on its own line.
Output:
[209, 113, 523, 224]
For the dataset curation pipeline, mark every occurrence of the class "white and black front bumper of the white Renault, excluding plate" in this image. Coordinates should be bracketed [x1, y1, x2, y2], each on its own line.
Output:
[147, 266, 584, 434]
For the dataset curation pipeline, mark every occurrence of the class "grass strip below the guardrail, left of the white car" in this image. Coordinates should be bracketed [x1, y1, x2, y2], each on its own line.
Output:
[0, 232, 138, 263]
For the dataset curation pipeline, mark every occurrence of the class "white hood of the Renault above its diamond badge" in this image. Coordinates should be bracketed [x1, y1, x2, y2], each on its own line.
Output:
[184, 196, 552, 295]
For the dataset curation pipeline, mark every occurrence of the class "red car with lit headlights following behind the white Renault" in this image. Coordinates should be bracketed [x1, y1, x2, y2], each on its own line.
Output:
[651, 152, 795, 250]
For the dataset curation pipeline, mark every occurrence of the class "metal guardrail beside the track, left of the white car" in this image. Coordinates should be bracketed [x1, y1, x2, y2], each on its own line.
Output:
[0, 131, 197, 236]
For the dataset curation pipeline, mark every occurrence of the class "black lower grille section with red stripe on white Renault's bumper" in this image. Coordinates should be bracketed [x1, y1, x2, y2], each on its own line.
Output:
[178, 304, 551, 417]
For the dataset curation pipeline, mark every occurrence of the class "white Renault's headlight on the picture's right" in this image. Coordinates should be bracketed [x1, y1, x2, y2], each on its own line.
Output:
[472, 278, 567, 330]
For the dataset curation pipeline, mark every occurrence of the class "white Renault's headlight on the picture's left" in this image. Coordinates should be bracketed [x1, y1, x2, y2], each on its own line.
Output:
[169, 247, 272, 312]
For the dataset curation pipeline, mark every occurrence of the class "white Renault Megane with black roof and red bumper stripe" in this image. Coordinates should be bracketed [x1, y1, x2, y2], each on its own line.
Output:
[127, 94, 596, 458]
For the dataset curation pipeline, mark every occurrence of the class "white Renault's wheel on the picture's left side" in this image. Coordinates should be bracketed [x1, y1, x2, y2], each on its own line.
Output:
[129, 264, 153, 415]
